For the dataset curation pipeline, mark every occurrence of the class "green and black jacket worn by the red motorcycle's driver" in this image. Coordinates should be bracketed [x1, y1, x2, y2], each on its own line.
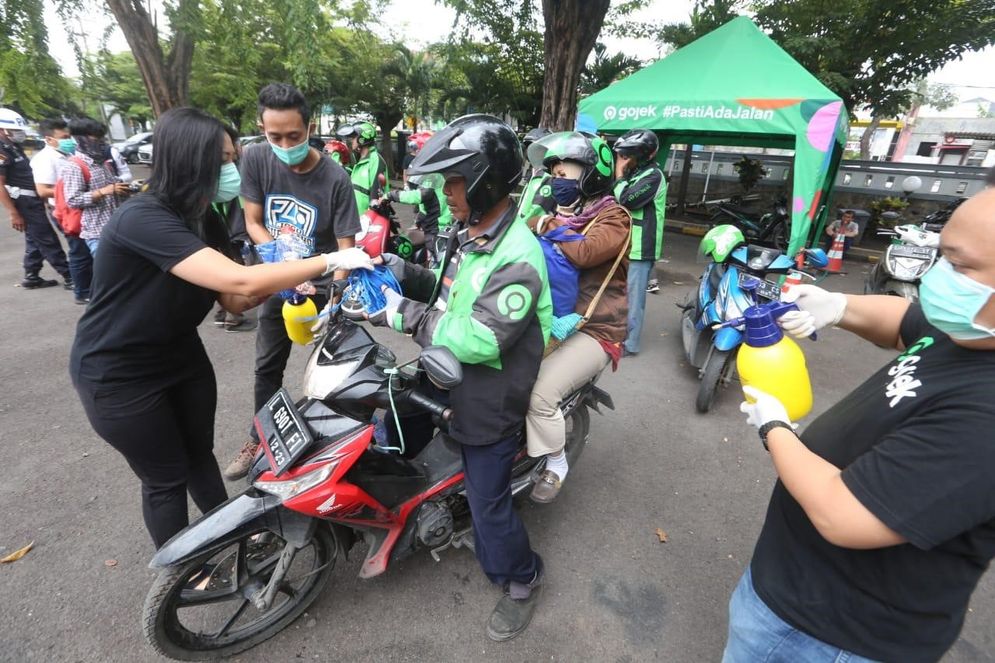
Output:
[387, 207, 553, 445]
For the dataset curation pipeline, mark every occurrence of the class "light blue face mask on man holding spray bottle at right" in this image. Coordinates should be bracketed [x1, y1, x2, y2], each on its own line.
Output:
[919, 258, 995, 341]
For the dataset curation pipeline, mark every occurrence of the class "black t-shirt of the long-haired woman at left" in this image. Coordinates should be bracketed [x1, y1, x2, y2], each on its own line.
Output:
[69, 194, 217, 383]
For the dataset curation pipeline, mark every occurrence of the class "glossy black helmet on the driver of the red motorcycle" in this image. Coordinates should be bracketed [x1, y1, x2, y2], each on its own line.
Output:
[408, 114, 522, 224]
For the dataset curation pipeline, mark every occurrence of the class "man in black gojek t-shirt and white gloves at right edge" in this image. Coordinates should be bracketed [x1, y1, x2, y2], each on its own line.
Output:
[723, 189, 995, 663]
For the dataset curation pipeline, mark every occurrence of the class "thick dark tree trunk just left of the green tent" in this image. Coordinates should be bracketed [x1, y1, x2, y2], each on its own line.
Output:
[539, 0, 611, 131]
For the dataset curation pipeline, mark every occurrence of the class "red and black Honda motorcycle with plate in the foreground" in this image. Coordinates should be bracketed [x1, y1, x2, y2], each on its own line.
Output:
[142, 284, 614, 661]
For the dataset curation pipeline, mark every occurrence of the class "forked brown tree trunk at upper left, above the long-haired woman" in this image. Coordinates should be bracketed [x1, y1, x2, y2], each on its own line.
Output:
[107, 0, 198, 117]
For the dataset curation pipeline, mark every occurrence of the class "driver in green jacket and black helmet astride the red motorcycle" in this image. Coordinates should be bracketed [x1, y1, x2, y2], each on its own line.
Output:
[370, 115, 553, 641]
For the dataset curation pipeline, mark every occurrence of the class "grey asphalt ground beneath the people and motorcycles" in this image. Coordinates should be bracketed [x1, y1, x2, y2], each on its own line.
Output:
[0, 188, 995, 663]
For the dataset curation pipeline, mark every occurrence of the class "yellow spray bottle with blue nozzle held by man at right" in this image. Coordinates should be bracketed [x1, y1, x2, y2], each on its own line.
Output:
[726, 302, 812, 421]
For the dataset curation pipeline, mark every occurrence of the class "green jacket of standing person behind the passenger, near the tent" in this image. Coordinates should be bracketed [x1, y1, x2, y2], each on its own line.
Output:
[614, 164, 667, 260]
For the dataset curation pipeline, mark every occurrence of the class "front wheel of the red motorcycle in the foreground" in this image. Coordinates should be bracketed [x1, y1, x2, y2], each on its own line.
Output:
[142, 525, 338, 661]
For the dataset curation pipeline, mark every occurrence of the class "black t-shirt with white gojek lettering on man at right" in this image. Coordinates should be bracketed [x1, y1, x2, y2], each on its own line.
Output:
[751, 306, 995, 661]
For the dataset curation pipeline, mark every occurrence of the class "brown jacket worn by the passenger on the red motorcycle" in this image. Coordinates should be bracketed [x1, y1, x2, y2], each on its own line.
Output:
[541, 204, 632, 343]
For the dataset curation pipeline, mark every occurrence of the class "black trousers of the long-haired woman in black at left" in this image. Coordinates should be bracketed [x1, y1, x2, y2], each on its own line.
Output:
[75, 356, 228, 548]
